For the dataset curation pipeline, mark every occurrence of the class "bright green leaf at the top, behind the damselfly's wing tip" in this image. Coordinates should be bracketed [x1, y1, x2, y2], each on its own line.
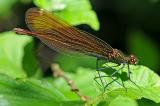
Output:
[34, 0, 99, 30]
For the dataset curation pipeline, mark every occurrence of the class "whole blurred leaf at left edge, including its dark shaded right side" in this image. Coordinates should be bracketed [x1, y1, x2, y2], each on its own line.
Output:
[0, 32, 41, 78]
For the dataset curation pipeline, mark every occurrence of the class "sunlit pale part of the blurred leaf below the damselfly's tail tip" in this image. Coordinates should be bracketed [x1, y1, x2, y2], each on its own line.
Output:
[0, 32, 32, 78]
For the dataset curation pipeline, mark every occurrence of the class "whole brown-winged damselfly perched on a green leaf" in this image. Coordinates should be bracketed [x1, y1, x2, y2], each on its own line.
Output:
[14, 8, 137, 89]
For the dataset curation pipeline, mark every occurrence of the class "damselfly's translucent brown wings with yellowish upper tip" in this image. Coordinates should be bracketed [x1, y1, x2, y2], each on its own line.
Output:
[26, 8, 113, 57]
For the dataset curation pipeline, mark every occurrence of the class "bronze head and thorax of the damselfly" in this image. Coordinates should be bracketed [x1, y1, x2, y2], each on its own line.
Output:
[108, 49, 138, 64]
